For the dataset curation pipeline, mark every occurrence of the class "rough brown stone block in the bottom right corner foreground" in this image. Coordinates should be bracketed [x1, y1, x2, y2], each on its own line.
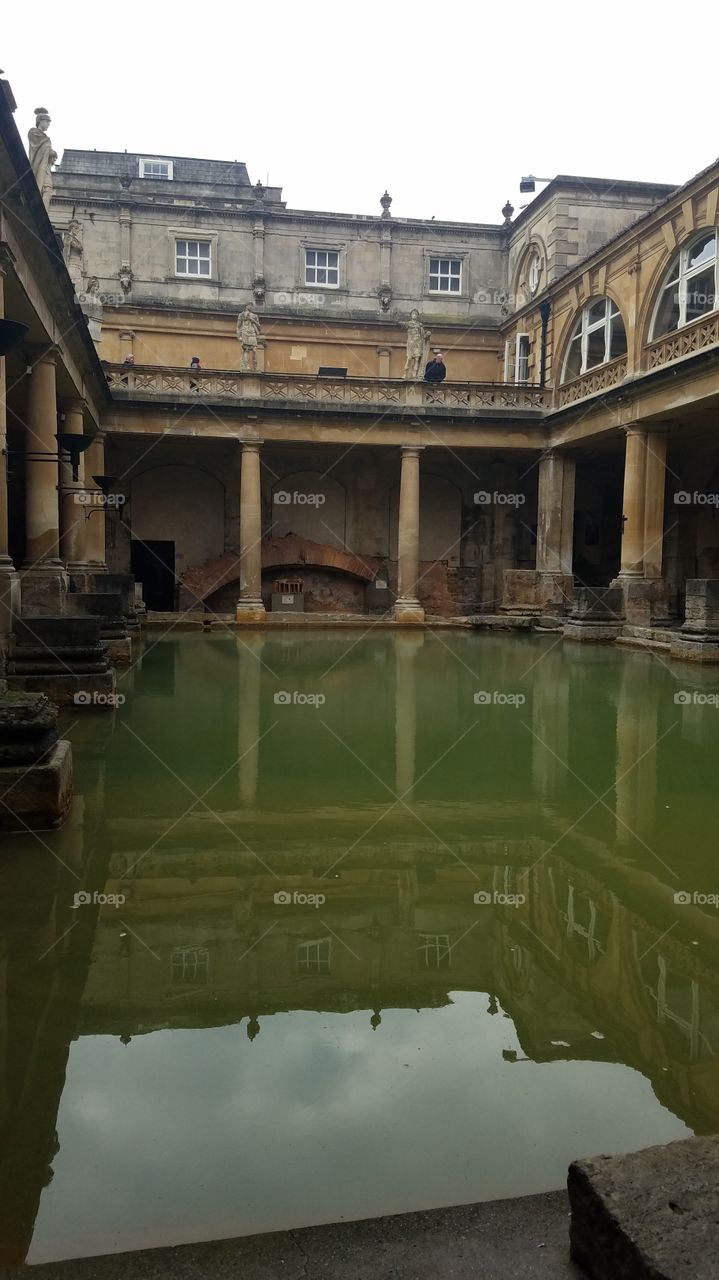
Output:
[567, 1137, 719, 1280]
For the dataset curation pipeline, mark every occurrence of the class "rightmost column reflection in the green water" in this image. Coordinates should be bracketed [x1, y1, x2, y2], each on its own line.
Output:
[615, 658, 658, 844]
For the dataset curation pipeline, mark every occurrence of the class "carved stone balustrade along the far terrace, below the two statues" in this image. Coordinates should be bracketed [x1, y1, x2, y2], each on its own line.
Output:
[105, 365, 550, 416]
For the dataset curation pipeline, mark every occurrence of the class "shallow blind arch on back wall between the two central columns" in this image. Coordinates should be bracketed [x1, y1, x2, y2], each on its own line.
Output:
[270, 470, 347, 549]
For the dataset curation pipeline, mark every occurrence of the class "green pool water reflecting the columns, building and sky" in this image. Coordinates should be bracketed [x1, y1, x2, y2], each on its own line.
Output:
[0, 631, 719, 1262]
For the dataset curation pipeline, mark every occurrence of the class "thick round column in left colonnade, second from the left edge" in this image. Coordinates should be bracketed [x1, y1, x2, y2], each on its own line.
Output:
[22, 348, 67, 614]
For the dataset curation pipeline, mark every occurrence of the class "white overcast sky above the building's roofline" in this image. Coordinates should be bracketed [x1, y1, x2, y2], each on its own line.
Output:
[1, 0, 719, 223]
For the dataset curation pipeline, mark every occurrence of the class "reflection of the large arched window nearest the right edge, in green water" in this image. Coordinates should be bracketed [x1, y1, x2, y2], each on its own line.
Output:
[632, 933, 719, 1061]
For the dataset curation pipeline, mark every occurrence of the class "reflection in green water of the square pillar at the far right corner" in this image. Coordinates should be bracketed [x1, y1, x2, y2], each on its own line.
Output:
[522, 648, 569, 797]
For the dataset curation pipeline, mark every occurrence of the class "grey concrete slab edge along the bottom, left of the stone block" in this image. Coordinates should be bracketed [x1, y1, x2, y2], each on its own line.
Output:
[0, 1190, 582, 1280]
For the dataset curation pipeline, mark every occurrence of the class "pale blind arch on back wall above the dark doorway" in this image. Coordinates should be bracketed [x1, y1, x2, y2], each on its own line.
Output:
[129, 462, 225, 568]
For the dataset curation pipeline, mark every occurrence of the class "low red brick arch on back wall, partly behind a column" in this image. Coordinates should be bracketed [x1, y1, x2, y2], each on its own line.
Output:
[180, 534, 380, 602]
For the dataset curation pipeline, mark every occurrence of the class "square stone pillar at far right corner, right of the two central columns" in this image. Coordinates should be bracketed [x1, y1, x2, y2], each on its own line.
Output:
[536, 451, 576, 612]
